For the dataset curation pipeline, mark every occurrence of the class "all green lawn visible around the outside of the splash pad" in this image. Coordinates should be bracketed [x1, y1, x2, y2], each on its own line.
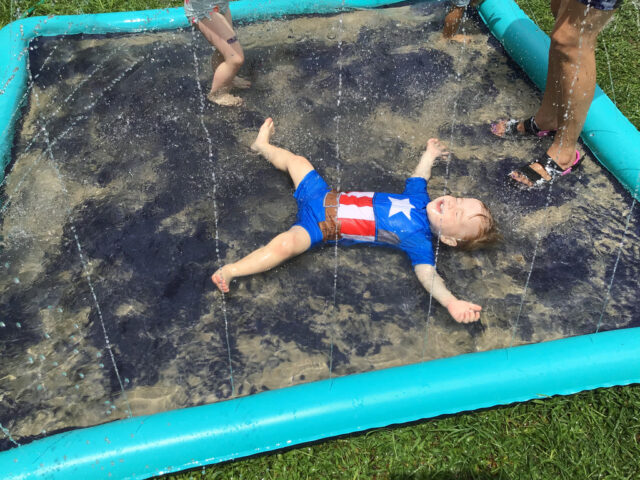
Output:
[0, 0, 640, 480]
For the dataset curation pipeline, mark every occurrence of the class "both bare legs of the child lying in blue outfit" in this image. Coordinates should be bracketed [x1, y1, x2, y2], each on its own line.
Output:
[211, 118, 313, 292]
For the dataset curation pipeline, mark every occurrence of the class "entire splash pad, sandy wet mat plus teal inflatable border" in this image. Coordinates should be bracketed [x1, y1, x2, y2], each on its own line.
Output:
[0, 0, 639, 478]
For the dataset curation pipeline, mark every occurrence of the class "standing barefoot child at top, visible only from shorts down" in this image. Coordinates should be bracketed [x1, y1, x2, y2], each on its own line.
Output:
[184, 0, 250, 107]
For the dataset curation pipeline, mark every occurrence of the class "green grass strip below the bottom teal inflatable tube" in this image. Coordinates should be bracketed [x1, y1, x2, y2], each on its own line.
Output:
[164, 387, 640, 480]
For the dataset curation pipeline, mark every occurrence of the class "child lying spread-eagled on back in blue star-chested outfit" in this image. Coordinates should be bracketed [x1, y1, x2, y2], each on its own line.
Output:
[211, 118, 498, 323]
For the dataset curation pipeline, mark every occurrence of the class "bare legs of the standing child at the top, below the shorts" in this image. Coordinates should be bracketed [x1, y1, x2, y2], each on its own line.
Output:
[197, 13, 244, 106]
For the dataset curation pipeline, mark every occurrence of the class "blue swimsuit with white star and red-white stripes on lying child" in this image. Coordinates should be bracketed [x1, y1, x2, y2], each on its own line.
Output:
[293, 170, 434, 266]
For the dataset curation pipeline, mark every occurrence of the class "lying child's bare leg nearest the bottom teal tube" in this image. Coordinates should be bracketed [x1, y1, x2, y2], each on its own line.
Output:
[211, 225, 311, 293]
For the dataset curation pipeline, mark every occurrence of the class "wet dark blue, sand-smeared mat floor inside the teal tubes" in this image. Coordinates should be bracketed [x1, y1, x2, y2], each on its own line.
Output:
[0, 0, 640, 450]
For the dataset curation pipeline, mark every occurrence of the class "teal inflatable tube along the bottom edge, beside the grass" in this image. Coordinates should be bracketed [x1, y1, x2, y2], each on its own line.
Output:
[0, 329, 640, 480]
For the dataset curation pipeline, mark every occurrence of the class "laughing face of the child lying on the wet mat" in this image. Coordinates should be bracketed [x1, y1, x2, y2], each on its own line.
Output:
[427, 195, 485, 240]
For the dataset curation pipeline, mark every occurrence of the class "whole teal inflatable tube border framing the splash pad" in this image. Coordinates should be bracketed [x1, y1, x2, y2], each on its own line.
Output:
[0, 0, 640, 480]
